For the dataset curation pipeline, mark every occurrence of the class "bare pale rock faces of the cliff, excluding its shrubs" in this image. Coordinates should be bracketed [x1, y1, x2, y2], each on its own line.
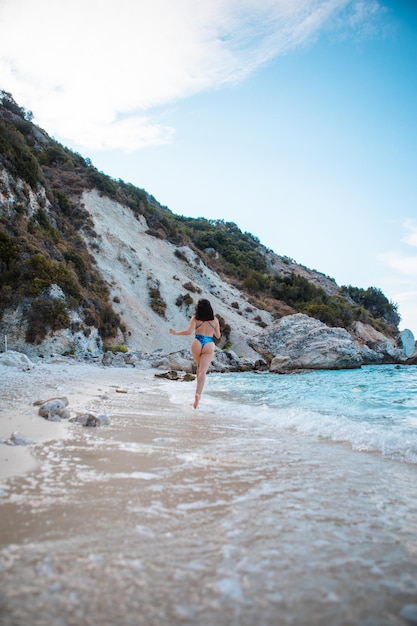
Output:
[0, 170, 410, 372]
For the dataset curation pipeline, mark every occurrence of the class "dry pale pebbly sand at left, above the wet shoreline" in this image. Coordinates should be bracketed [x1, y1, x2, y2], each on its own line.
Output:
[0, 359, 166, 480]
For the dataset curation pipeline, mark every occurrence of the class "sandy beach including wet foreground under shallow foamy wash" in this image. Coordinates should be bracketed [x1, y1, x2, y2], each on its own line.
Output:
[0, 360, 417, 626]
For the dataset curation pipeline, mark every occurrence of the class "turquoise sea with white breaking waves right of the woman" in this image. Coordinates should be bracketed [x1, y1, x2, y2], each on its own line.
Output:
[198, 365, 417, 463]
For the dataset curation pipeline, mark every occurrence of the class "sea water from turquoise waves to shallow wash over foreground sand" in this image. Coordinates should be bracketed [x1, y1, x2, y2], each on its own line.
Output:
[0, 365, 417, 626]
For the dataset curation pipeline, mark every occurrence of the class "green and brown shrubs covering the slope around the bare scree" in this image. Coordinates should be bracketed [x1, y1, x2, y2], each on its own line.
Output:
[0, 91, 400, 341]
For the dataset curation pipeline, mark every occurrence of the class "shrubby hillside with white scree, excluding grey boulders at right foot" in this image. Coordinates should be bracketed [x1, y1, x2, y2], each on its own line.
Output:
[0, 92, 399, 355]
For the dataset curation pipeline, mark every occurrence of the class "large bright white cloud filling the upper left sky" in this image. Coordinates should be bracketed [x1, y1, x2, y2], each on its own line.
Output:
[0, 0, 386, 149]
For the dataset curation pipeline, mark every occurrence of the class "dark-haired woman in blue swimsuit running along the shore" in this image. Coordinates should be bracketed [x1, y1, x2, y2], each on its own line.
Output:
[169, 298, 220, 409]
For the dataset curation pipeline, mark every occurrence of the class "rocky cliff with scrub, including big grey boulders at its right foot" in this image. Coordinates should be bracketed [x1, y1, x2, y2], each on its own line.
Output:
[0, 91, 415, 372]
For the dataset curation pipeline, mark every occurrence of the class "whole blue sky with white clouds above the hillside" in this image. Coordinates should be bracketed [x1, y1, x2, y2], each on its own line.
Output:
[0, 0, 417, 339]
